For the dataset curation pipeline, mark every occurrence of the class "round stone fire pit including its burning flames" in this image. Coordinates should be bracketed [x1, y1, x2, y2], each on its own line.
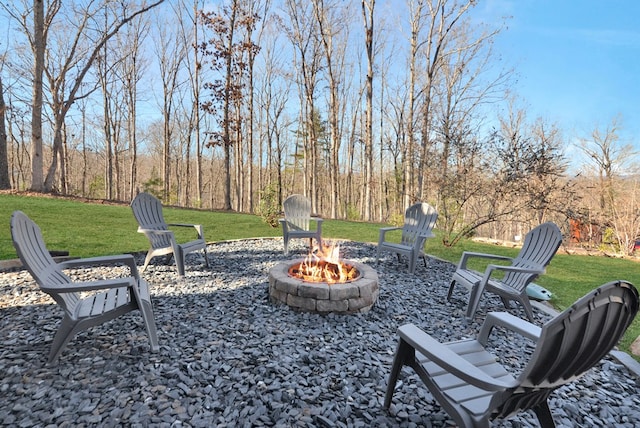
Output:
[269, 244, 379, 314]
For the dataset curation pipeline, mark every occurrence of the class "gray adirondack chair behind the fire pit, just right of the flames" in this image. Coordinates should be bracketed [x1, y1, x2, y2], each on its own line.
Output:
[376, 202, 438, 273]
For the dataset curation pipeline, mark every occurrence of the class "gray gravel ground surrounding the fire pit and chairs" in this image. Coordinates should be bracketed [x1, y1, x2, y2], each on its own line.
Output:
[0, 239, 640, 427]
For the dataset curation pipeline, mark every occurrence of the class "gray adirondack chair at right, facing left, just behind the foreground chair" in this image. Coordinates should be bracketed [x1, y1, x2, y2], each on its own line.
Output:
[447, 222, 562, 322]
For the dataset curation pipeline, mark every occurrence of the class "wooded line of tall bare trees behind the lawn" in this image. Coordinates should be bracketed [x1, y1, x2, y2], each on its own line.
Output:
[0, 0, 640, 252]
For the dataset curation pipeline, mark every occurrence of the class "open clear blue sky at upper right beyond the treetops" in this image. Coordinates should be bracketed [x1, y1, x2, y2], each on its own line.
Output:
[477, 0, 640, 148]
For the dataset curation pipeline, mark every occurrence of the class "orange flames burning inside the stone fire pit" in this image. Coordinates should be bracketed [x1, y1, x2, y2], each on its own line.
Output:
[289, 243, 359, 284]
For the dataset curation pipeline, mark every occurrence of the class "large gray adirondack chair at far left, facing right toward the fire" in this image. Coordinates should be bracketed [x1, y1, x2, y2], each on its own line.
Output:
[11, 211, 159, 364]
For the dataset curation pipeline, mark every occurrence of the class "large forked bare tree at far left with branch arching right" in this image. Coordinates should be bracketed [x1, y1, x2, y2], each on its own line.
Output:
[7, 0, 164, 192]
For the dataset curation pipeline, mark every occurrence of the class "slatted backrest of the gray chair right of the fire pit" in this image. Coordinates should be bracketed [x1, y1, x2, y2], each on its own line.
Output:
[502, 222, 562, 291]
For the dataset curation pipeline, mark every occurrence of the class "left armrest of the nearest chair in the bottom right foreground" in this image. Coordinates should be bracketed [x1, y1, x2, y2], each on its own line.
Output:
[398, 324, 516, 391]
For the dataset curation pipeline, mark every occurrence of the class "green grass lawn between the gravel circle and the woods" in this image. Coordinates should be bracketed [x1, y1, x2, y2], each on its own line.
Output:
[0, 194, 640, 358]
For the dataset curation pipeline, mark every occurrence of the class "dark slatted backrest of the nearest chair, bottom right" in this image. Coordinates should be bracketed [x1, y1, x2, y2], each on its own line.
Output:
[497, 281, 640, 417]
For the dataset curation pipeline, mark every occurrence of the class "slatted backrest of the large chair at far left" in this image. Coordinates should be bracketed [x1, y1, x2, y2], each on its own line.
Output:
[11, 211, 80, 313]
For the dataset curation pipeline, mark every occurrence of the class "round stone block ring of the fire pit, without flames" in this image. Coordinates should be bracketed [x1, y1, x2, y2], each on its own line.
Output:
[269, 259, 380, 314]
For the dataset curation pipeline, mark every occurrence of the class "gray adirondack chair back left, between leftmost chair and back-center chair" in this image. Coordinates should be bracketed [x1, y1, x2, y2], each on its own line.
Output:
[131, 192, 209, 276]
